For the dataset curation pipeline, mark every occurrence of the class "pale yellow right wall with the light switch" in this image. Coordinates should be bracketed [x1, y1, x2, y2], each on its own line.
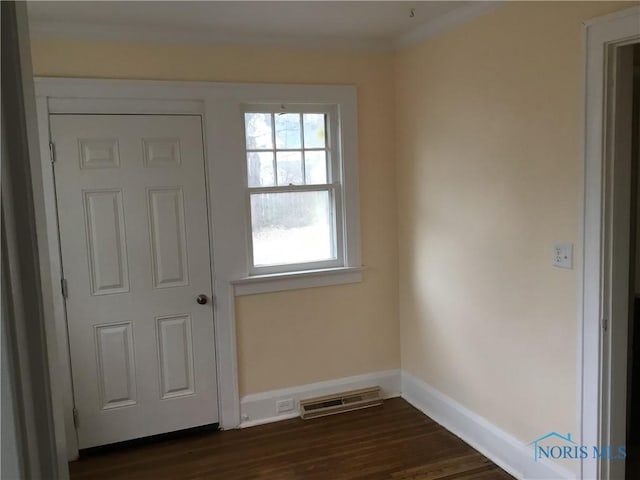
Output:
[396, 2, 630, 450]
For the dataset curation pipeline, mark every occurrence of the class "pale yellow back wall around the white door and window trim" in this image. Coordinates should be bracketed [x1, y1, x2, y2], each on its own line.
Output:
[32, 38, 400, 395]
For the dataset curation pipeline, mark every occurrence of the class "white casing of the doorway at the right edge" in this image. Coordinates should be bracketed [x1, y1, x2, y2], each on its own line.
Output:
[577, 7, 640, 480]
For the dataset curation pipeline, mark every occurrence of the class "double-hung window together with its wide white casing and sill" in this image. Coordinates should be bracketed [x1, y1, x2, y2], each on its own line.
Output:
[226, 84, 363, 295]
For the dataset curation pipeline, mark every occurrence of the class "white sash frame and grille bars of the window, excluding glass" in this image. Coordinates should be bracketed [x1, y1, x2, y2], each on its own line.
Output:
[243, 104, 346, 276]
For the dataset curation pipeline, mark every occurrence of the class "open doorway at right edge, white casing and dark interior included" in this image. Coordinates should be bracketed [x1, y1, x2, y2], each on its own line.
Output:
[577, 7, 640, 480]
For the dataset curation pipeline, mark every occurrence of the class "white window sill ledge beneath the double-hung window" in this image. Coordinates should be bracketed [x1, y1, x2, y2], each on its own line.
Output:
[231, 267, 363, 297]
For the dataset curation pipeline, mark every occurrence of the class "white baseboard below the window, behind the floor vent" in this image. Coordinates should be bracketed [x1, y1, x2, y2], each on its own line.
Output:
[240, 370, 401, 428]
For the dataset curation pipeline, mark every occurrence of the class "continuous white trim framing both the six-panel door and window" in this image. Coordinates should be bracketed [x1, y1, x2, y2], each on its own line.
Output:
[35, 77, 362, 460]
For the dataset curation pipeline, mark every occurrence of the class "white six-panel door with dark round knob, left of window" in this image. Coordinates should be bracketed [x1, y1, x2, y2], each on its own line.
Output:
[50, 115, 218, 448]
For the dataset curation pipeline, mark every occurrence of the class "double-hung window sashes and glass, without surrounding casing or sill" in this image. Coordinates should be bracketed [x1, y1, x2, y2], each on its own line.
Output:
[244, 105, 345, 275]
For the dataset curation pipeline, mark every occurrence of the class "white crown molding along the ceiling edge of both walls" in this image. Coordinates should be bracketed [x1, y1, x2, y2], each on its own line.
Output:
[29, 1, 503, 53]
